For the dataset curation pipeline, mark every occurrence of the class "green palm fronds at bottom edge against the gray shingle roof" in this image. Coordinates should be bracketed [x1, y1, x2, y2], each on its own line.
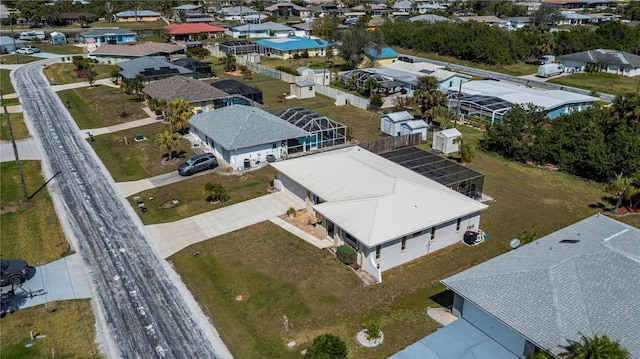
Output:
[560, 334, 629, 359]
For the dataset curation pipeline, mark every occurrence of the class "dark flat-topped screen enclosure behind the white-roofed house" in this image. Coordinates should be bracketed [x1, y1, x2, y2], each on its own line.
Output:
[380, 147, 484, 198]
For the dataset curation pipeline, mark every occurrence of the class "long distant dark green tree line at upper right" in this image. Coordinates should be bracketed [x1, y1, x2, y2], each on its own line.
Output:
[380, 20, 640, 65]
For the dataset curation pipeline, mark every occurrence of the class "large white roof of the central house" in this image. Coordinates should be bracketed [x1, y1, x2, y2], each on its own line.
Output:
[271, 146, 487, 247]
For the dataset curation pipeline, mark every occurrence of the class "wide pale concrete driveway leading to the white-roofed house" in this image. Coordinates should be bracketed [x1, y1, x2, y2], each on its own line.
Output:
[143, 192, 304, 258]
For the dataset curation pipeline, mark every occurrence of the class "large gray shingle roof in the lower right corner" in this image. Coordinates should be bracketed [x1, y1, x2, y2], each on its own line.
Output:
[442, 215, 640, 358]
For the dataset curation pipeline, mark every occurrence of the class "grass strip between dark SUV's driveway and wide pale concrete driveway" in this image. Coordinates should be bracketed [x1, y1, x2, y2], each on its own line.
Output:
[128, 166, 276, 224]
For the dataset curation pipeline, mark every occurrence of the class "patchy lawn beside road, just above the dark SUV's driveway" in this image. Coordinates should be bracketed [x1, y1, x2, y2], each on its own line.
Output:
[89, 121, 199, 183]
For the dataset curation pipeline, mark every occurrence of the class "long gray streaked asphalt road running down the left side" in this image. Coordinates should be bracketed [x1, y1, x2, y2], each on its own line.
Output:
[11, 60, 232, 359]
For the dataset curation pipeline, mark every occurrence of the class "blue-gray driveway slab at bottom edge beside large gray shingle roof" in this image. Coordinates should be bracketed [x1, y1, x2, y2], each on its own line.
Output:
[389, 319, 518, 359]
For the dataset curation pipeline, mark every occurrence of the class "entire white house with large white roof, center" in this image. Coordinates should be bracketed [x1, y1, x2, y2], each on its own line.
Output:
[268, 148, 487, 282]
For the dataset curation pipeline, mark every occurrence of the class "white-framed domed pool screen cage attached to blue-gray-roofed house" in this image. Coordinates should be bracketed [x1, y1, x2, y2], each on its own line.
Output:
[275, 107, 347, 154]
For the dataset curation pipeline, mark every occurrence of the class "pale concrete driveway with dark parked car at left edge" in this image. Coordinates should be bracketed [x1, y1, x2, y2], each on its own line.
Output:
[1, 254, 91, 313]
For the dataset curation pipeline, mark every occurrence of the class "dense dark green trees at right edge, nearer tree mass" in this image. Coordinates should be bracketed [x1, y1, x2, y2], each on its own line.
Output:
[480, 94, 640, 182]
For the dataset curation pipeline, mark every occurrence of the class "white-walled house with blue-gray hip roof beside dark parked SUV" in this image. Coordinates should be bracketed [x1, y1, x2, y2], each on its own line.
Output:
[189, 105, 309, 169]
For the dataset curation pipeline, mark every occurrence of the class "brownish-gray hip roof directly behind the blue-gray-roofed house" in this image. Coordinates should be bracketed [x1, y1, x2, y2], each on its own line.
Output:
[142, 76, 231, 102]
